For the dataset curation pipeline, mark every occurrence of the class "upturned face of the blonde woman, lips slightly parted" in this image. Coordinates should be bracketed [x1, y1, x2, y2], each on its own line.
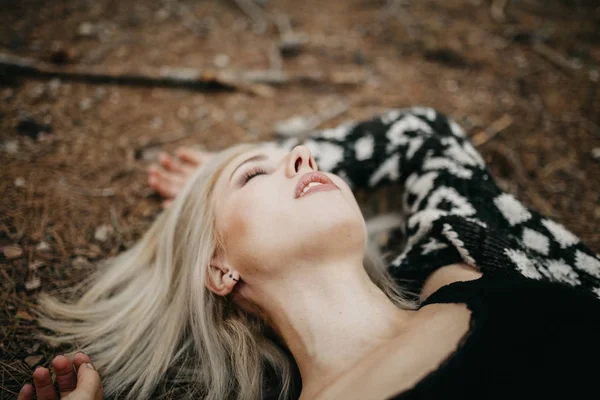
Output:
[213, 146, 367, 283]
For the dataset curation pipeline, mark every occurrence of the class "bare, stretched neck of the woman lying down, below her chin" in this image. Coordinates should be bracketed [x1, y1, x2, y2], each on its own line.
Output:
[248, 260, 411, 394]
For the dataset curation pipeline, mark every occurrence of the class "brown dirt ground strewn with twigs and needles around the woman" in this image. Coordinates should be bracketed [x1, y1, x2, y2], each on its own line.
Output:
[0, 0, 600, 399]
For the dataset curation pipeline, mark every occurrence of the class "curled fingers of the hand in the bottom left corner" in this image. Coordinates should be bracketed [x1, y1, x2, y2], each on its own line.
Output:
[18, 352, 103, 400]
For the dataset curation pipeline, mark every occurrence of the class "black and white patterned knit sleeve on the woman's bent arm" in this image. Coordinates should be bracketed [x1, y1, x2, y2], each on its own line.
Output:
[272, 107, 600, 297]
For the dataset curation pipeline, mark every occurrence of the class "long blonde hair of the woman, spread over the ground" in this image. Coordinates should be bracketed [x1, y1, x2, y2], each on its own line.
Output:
[38, 145, 413, 400]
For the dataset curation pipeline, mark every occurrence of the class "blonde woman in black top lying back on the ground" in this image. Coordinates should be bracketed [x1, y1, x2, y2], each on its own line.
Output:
[17, 108, 600, 400]
